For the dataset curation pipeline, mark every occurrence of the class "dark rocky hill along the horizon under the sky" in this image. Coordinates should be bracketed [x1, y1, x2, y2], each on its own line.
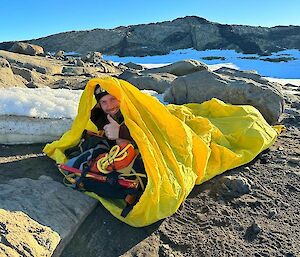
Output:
[0, 16, 300, 56]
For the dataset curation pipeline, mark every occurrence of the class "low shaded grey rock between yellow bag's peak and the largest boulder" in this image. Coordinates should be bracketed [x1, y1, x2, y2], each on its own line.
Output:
[119, 71, 177, 93]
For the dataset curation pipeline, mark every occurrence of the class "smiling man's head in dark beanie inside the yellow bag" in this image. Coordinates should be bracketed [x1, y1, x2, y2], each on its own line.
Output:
[95, 85, 120, 117]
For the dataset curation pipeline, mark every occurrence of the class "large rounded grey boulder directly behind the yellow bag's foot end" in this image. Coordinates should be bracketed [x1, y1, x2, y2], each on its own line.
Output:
[164, 70, 284, 124]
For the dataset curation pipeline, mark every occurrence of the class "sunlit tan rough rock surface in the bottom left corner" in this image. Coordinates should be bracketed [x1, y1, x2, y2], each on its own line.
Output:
[0, 209, 60, 257]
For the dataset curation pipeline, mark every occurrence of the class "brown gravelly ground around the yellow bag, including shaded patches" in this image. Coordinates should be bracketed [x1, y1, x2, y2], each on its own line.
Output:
[0, 87, 300, 257]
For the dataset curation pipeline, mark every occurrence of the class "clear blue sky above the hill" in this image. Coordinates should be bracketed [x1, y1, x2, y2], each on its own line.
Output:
[0, 0, 300, 42]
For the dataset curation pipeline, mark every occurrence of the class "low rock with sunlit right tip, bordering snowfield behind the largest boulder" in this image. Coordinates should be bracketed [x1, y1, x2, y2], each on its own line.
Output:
[145, 60, 208, 76]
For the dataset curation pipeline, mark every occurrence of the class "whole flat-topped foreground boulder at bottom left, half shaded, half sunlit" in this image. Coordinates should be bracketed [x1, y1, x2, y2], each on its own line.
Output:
[0, 175, 97, 256]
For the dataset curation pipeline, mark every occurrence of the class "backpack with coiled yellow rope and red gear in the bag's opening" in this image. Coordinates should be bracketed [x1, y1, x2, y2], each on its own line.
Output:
[58, 131, 147, 217]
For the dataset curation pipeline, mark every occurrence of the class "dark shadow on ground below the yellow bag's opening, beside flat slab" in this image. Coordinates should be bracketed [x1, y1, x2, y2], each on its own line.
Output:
[61, 204, 161, 257]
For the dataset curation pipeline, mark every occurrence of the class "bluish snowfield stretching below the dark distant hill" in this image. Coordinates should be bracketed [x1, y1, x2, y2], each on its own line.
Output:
[103, 48, 300, 79]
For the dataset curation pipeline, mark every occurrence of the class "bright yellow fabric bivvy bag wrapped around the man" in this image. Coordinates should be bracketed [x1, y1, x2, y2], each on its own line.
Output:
[44, 77, 280, 227]
